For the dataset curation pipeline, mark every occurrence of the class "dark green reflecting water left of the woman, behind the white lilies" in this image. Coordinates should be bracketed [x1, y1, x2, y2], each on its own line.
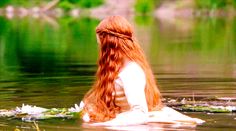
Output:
[0, 18, 99, 108]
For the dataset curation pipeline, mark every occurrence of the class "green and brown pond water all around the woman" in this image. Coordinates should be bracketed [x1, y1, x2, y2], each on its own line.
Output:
[0, 16, 236, 131]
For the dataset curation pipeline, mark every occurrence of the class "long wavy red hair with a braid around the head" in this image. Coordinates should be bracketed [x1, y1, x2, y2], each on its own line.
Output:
[83, 16, 162, 122]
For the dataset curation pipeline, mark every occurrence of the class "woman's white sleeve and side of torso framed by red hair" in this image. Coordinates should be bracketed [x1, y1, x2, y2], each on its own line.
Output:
[113, 61, 148, 112]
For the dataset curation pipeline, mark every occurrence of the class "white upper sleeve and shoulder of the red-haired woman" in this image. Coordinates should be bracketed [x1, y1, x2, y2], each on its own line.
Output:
[115, 62, 148, 113]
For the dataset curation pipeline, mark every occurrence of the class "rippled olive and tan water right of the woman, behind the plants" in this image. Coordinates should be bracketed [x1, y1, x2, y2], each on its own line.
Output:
[138, 18, 236, 97]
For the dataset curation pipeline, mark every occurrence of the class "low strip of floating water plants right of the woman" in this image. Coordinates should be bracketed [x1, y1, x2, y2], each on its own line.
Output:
[163, 97, 236, 113]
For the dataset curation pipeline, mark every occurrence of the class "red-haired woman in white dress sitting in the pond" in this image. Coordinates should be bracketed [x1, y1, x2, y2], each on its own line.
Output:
[83, 16, 203, 126]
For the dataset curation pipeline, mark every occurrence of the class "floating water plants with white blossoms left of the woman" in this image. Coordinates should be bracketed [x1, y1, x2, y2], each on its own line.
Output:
[0, 104, 83, 122]
